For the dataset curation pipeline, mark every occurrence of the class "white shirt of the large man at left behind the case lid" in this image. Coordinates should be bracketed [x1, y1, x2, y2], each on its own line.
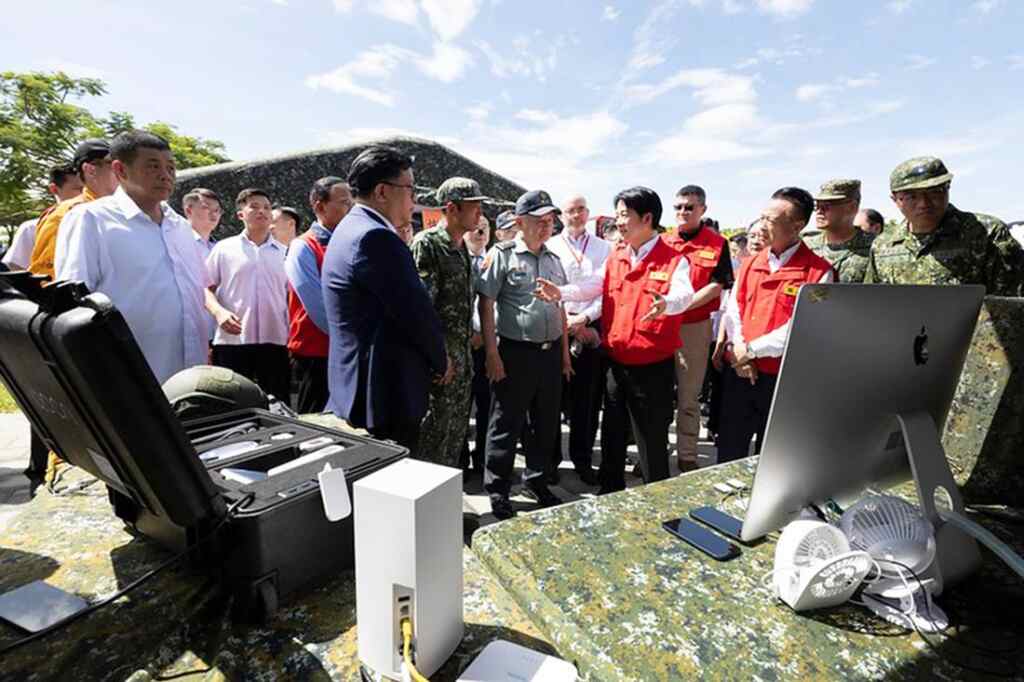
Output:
[53, 188, 210, 383]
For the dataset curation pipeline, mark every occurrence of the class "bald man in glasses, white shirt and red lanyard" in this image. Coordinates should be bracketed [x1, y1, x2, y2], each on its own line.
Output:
[547, 195, 611, 485]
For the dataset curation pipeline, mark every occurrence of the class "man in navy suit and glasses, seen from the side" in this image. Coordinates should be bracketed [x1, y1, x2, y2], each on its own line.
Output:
[323, 146, 451, 457]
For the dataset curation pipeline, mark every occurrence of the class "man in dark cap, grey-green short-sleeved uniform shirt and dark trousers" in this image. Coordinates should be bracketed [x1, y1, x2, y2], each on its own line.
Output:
[476, 190, 571, 518]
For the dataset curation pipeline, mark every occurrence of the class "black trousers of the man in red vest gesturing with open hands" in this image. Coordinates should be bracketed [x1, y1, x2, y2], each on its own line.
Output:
[598, 357, 676, 493]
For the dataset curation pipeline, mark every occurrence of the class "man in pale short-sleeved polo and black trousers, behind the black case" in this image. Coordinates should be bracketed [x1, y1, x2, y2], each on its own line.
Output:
[206, 187, 291, 403]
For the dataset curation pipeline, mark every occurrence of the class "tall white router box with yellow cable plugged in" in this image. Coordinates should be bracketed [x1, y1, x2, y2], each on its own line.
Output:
[352, 459, 463, 680]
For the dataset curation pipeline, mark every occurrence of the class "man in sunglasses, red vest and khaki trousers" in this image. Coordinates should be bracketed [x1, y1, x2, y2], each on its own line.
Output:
[666, 184, 732, 471]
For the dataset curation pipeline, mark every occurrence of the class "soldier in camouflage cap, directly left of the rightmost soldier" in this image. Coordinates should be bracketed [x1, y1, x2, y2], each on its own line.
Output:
[804, 179, 873, 284]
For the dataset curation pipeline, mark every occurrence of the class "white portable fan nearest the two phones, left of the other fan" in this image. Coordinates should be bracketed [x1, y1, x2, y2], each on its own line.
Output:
[772, 519, 872, 611]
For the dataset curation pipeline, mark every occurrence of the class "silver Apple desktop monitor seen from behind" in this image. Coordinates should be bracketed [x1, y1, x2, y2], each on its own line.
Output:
[742, 285, 985, 579]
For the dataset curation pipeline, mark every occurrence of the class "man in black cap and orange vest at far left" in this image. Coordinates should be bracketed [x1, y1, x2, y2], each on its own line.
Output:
[29, 139, 118, 278]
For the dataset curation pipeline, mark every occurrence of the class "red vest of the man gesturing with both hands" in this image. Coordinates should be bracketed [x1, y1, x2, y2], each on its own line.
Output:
[601, 238, 683, 365]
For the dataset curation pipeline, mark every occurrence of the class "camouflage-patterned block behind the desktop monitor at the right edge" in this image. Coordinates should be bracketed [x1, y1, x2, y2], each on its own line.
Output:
[942, 296, 1024, 507]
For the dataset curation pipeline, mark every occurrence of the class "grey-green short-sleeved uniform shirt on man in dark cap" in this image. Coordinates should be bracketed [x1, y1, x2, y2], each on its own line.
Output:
[476, 237, 567, 343]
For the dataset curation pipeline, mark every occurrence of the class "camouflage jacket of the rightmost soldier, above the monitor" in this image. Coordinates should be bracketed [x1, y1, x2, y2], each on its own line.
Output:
[864, 204, 1024, 296]
